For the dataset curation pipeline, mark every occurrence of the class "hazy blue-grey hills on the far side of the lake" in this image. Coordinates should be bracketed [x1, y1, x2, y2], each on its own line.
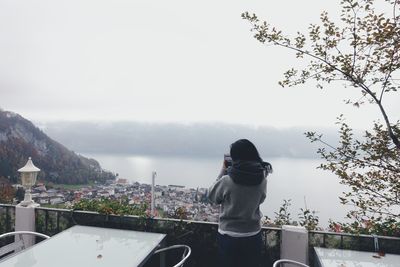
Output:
[38, 121, 337, 158]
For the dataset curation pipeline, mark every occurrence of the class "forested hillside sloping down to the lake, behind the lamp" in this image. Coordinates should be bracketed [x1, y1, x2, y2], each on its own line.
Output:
[0, 110, 115, 184]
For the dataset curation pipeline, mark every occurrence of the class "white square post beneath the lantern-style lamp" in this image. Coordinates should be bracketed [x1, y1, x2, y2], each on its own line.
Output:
[15, 203, 40, 250]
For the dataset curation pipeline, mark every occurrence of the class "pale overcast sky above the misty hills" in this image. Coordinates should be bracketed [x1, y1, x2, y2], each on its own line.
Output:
[0, 0, 400, 128]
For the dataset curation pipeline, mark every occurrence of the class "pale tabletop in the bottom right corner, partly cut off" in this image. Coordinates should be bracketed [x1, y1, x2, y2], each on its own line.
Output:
[314, 248, 400, 267]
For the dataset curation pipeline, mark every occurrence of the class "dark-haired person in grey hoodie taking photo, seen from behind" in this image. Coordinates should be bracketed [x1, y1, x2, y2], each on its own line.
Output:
[208, 139, 272, 267]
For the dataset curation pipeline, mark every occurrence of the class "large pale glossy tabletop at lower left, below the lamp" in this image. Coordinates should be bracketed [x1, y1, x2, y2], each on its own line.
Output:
[0, 225, 165, 267]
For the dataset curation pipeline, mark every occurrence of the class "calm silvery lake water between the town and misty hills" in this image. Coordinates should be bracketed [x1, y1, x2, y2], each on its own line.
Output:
[84, 154, 347, 226]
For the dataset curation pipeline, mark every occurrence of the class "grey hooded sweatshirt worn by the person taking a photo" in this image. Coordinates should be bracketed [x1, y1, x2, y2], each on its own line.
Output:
[208, 161, 267, 233]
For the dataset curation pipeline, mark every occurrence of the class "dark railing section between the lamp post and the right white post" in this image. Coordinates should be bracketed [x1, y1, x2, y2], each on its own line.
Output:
[35, 208, 281, 267]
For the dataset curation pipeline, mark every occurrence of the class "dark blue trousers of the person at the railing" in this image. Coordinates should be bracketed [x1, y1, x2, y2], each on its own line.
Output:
[217, 232, 262, 267]
